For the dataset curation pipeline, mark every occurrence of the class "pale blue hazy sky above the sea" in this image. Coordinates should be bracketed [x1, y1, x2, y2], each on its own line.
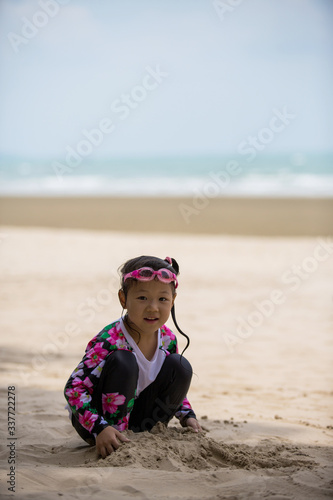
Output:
[0, 0, 333, 158]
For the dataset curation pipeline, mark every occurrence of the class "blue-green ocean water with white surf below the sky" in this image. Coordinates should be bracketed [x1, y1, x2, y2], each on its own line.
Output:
[0, 153, 333, 198]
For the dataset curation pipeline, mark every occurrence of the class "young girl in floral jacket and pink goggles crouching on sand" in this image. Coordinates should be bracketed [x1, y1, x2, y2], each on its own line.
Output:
[65, 256, 202, 458]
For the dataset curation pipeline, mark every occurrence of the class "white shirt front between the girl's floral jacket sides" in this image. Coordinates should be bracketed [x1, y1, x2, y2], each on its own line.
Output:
[120, 318, 166, 397]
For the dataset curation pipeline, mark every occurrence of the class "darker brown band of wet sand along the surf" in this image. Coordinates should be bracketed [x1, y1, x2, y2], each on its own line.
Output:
[0, 193, 333, 236]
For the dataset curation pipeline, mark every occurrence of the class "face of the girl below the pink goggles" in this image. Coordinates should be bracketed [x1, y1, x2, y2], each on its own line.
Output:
[119, 278, 177, 334]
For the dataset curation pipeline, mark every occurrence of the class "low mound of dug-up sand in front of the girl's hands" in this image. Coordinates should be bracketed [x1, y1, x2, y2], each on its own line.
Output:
[85, 423, 315, 472]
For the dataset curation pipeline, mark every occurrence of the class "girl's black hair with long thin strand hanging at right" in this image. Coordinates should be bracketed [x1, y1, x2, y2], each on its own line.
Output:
[119, 255, 190, 355]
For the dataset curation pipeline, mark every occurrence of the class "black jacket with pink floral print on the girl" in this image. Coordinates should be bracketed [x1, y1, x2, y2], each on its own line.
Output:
[64, 320, 194, 437]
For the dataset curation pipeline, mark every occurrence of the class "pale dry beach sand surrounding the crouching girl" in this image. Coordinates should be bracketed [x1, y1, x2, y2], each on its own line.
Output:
[0, 225, 333, 500]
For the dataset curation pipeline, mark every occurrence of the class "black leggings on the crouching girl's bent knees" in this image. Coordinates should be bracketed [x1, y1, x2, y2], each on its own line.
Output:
[72, 350, 195, 444]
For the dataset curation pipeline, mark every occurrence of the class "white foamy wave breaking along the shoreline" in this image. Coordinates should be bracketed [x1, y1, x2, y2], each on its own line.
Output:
[0, 173, 333, 197]
